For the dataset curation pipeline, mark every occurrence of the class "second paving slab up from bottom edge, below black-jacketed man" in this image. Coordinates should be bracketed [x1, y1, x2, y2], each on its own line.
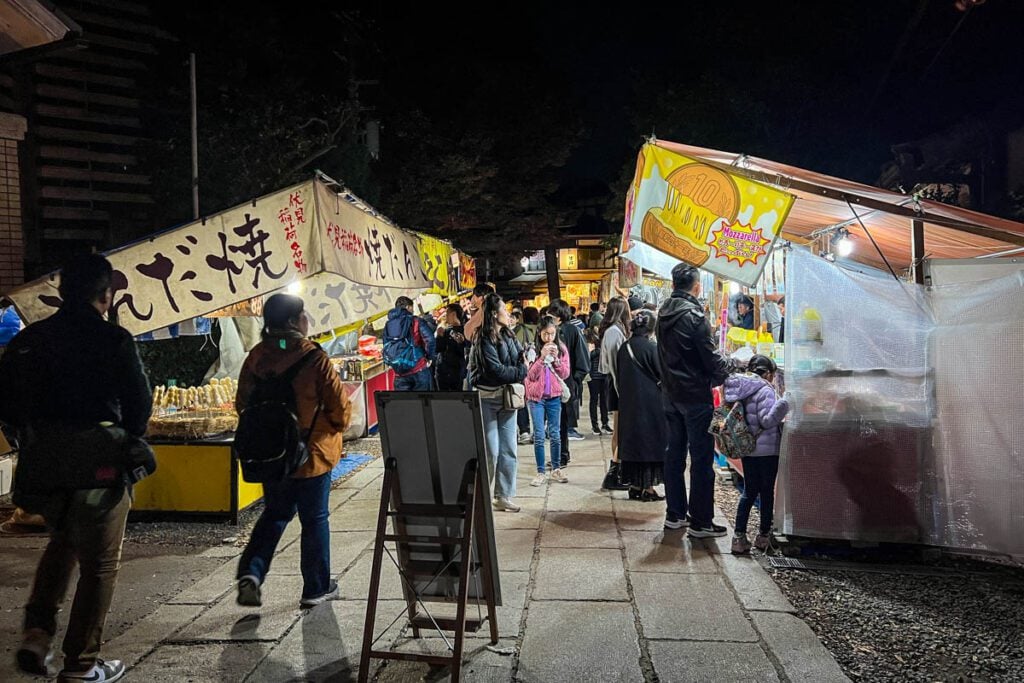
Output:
[630, 572, 758, 642]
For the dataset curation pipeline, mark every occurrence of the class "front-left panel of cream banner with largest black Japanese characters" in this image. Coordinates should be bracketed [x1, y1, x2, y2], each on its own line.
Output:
[7, 181, 318, 335]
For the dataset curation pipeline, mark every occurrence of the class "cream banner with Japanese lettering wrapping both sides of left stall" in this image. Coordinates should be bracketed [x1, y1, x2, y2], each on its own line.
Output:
[6, 179, 464, 336]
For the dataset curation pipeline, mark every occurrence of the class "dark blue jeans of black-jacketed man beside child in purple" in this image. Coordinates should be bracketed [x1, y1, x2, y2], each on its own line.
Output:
[665, 400, 715, 528]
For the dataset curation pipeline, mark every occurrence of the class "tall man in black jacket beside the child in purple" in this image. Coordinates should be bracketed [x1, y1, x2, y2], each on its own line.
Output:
[657, 263, 734, 539]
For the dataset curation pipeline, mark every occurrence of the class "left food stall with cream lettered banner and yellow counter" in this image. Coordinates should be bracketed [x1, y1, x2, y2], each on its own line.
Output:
[4, 174, 475, 519]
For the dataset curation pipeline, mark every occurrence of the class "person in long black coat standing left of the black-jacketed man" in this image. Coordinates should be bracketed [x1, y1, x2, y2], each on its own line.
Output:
[616, 310, 669, 501]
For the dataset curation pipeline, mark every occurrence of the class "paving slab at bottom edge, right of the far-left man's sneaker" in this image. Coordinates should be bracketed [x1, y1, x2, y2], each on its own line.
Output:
[122, 643, 271, 683]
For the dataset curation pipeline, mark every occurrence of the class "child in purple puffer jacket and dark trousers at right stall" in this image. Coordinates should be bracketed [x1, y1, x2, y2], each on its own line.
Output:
[725, 354, 790, 555]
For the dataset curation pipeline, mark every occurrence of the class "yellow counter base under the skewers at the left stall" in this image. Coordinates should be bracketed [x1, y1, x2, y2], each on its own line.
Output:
[132, 438, 263, 523]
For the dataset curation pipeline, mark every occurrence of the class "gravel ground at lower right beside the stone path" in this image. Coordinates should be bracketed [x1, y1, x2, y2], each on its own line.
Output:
[716, 473, 1024, 682]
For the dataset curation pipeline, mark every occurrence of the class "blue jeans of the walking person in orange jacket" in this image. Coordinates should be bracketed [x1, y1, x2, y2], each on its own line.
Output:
[238, 472, 331, 598]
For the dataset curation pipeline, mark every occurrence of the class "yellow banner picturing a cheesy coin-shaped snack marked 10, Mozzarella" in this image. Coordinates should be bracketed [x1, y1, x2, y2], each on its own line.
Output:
[620, 143, 795, 287]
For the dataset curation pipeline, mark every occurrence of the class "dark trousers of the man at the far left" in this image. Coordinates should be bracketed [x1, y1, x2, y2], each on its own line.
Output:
[25, 488, 131, 671]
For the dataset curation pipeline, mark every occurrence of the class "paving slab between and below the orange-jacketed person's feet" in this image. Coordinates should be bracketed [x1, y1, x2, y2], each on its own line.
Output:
[170, 574, 302, 642]
